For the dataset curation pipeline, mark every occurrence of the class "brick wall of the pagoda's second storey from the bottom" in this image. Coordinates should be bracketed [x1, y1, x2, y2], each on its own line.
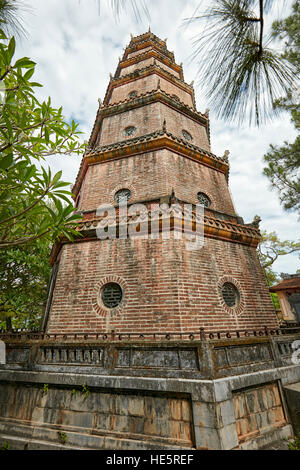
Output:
[79, 150, 235, 214]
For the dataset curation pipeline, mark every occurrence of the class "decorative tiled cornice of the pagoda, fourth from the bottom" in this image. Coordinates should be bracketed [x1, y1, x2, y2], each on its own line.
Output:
[103, 64, 195, 105]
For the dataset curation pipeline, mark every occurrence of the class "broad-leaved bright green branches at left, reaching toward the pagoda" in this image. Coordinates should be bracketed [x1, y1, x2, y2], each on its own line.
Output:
[0, 31, 84, 249]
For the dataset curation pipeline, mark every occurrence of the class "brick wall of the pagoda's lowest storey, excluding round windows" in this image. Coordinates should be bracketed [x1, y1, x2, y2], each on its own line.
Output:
[48, 238, 277, 333]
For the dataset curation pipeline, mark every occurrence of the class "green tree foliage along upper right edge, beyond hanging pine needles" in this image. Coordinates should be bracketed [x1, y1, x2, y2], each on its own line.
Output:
[264, 1, 300, 214]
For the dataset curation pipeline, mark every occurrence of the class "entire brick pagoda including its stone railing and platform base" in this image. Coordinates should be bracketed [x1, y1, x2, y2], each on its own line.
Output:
[0, 31, 300, 454]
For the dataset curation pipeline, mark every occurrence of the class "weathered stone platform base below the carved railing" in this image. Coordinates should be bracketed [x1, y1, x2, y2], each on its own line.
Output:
[0, 365, 300, 450]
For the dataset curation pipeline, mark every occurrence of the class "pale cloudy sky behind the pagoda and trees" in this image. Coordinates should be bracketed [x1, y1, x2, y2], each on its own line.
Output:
[16, 0, 300, 273]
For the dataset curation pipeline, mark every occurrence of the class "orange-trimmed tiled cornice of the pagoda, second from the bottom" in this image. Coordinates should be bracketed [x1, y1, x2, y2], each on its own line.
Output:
[72, 130, 229, 198]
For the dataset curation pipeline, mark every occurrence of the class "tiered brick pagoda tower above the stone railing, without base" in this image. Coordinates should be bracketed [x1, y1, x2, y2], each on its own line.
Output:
[42, 31, 278, 334]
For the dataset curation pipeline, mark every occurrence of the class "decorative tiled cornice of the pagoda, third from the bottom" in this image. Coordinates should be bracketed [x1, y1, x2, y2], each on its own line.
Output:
[88, 88, 209, 148]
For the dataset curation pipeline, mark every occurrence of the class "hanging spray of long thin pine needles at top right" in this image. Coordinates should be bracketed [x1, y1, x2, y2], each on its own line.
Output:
[187, 0, 295, 125]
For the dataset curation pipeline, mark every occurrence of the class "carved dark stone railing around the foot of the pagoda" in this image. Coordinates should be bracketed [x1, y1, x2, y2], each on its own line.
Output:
[0, 328, 300, 379]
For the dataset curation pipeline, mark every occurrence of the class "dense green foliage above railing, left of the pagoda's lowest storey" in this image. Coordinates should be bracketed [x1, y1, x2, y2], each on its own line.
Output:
[0, 239, 51, 330]
